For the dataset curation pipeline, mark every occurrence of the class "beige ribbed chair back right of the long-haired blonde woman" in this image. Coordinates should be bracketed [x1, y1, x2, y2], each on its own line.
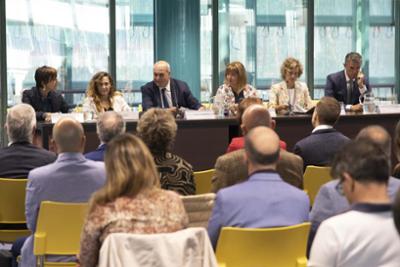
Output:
[181, 193, 215, 228]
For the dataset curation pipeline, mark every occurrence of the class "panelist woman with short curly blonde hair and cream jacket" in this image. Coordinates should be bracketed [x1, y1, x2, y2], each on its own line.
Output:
[269, 57, 313, 114]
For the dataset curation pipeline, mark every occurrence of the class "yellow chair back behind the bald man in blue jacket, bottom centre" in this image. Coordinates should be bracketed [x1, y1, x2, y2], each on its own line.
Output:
[216, 223, 310, 267]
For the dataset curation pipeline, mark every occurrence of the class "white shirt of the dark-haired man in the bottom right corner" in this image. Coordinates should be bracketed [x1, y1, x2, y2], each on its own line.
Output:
[308, 207, 400, 267]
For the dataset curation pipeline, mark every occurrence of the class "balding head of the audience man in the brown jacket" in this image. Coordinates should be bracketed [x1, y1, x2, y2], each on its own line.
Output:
[241, 105, 273, 135]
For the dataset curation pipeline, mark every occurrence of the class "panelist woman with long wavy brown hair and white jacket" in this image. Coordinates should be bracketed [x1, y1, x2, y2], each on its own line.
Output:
[83, 71, 130, 115]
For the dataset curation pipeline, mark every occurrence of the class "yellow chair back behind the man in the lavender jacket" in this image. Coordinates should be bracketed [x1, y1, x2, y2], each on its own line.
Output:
[33, 201, 88, 267]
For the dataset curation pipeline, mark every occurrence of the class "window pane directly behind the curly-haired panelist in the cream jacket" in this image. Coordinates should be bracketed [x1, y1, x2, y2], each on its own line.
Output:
[256, 0, 307, 96]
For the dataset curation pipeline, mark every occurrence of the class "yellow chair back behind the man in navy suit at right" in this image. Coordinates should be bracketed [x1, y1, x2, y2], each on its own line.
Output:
[303, 165, 332, 205]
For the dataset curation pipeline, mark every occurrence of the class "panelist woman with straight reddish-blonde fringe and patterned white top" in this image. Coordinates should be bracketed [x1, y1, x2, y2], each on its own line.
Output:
[215, 61, 259, 115]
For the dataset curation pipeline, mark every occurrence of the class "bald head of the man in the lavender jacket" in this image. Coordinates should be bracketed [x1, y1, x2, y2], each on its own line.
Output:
[53, 117, 85, 153]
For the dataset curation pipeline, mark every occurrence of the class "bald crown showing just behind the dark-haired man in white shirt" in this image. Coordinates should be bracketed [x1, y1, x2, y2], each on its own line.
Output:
[356, 125, 392, 157]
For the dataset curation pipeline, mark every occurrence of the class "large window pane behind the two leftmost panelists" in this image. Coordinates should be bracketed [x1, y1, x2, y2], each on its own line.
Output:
[6, 0, 109, 106]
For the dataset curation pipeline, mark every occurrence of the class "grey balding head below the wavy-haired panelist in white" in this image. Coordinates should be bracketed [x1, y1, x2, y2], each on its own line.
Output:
[97, 111, 125, 144]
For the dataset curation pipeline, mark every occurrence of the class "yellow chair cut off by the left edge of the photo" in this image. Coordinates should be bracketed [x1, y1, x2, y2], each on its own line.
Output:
[0, 178, 30, 243]
